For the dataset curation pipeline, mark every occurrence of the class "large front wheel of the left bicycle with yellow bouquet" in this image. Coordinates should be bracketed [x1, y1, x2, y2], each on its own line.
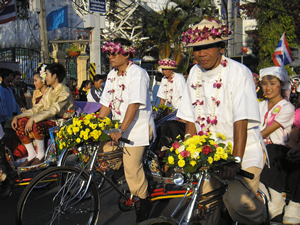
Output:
[17, 167, 100, 225]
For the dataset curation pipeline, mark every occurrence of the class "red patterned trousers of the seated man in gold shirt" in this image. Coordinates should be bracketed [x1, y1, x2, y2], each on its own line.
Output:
[16, 118, 56, 144]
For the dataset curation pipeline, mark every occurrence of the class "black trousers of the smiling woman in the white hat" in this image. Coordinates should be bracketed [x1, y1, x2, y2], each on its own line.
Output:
[260, 144, 300, 203]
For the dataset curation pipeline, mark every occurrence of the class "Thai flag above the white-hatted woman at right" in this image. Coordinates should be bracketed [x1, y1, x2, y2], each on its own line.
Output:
[272, 33, 295, 67]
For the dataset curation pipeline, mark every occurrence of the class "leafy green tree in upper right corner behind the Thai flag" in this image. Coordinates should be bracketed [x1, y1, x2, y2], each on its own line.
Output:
[241, 0, 300, 69]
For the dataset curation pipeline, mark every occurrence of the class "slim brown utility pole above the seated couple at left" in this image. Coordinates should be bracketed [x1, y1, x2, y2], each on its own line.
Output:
[39, 0, 50, 63]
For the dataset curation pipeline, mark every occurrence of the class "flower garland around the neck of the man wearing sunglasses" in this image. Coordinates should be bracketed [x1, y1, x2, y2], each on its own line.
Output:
[108, 60, 133, 115]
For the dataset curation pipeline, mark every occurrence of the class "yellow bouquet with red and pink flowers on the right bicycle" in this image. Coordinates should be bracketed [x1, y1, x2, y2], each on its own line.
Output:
[163, 133, 235, 173]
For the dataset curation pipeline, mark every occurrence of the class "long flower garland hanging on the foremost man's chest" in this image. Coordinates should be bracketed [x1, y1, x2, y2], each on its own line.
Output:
[191, 56, 227, 135]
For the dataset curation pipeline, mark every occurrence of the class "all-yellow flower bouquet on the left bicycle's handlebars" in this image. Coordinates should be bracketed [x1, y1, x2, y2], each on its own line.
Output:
[57, 113, 119, 149]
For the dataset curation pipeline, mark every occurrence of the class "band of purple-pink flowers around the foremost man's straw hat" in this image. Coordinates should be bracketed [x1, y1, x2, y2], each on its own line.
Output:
[181, 20, 232, 44]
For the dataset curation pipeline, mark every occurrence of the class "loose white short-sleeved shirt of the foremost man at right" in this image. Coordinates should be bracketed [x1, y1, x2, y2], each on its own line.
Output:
[177, 58, 265, 169]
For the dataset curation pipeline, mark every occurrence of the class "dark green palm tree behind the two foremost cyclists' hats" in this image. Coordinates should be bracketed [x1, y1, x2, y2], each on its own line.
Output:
[144, 0, 216, 72]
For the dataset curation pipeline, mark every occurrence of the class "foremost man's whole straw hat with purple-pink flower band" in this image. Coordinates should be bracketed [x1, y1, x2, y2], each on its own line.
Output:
[181, 19, 232, 47]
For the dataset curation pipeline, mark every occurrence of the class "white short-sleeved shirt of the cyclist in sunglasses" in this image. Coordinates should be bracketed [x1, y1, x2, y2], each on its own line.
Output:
[100, 64, 155, 147]
